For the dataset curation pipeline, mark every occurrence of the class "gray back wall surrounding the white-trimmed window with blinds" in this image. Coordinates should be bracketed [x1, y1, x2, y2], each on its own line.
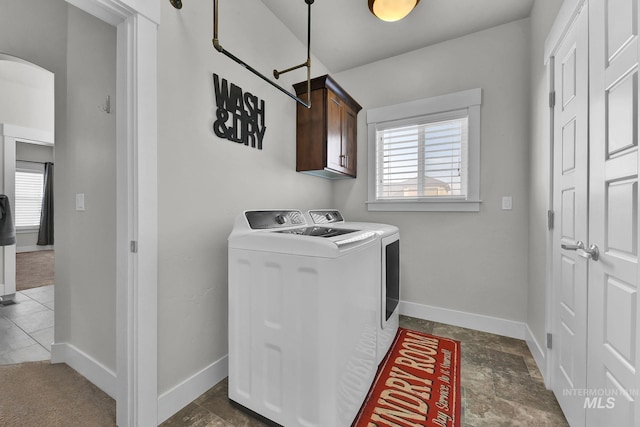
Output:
[334, 19, 529, 322]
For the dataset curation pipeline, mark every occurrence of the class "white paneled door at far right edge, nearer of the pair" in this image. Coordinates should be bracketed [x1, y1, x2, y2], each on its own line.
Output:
[585, 0, 640, 427]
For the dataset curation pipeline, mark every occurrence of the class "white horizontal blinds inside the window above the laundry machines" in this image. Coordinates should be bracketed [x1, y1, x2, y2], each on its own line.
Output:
[376, 109, 469, 200]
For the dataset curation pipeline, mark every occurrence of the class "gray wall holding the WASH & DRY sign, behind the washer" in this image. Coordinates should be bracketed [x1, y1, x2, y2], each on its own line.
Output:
[158, 0, 331, 394]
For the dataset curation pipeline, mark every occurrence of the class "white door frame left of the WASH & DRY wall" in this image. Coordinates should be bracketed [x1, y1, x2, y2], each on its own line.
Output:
[66, 0, 160, 427]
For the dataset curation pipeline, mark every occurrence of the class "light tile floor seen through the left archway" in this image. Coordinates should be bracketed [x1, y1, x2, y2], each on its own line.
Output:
[0, 285, 54, 365]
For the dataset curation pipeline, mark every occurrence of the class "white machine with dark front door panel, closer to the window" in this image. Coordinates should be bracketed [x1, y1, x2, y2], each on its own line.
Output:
[307, 209, 400, 364]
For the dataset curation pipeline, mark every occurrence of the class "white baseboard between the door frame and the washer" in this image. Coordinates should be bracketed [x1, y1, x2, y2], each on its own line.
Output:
[158, 355, 229, 424]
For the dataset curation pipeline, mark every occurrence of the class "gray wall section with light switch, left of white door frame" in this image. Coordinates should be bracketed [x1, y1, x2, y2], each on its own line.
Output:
[55, 6, 116, 372]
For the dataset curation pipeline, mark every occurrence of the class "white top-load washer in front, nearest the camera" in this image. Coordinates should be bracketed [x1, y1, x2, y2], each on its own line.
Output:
[228, 210, 380, 427]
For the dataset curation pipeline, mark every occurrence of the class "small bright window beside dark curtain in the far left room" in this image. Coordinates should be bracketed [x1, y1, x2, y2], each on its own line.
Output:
[15, 168, 44, 230]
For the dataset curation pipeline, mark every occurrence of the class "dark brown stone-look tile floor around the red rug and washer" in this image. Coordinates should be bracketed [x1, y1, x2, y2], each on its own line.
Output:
[161, 316, 568, 427]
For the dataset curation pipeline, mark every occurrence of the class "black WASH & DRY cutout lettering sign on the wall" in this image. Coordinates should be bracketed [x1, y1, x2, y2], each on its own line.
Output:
[213, 73, 267, 150]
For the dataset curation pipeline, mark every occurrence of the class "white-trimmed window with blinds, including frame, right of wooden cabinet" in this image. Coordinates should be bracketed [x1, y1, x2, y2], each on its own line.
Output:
[367, 89, 481, 212]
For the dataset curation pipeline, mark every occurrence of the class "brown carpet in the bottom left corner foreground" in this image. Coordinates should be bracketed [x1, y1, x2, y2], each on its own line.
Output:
[0, 361, 116, 427]
